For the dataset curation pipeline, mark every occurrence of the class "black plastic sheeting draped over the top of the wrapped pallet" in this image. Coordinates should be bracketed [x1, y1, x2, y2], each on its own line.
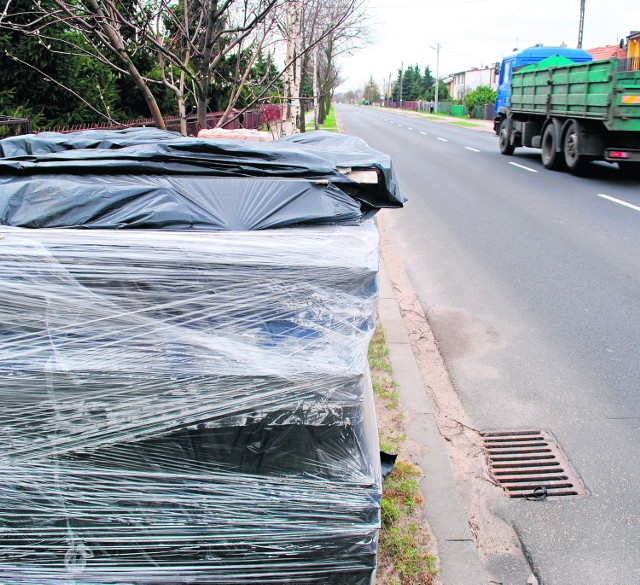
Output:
[0, 128, 405, 230]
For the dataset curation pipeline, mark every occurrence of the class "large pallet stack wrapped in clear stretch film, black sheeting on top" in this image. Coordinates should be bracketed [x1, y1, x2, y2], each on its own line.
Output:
[0, 125, 402, 585]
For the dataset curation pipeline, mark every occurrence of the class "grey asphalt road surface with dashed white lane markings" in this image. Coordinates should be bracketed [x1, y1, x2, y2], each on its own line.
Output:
[338, 106, 640, 585]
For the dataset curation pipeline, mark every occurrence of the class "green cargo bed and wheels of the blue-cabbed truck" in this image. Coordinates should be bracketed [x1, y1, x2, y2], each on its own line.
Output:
[496, 59, 640, 176]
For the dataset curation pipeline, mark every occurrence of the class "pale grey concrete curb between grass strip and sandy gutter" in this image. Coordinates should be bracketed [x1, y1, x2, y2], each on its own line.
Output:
[378, 262, 487, 585]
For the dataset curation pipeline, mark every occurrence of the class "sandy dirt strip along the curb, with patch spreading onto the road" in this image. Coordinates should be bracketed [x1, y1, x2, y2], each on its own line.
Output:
[378, 212, 529, 574]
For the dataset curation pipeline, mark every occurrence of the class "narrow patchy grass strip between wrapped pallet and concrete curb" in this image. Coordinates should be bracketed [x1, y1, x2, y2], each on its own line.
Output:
[369, 324, 437, 585]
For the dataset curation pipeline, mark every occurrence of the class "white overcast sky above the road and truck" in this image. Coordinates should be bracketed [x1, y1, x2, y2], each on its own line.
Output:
[337, 0, 640, 92]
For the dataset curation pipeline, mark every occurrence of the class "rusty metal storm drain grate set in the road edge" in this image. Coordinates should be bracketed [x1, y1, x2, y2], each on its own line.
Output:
[482, 431, 587, 500]
